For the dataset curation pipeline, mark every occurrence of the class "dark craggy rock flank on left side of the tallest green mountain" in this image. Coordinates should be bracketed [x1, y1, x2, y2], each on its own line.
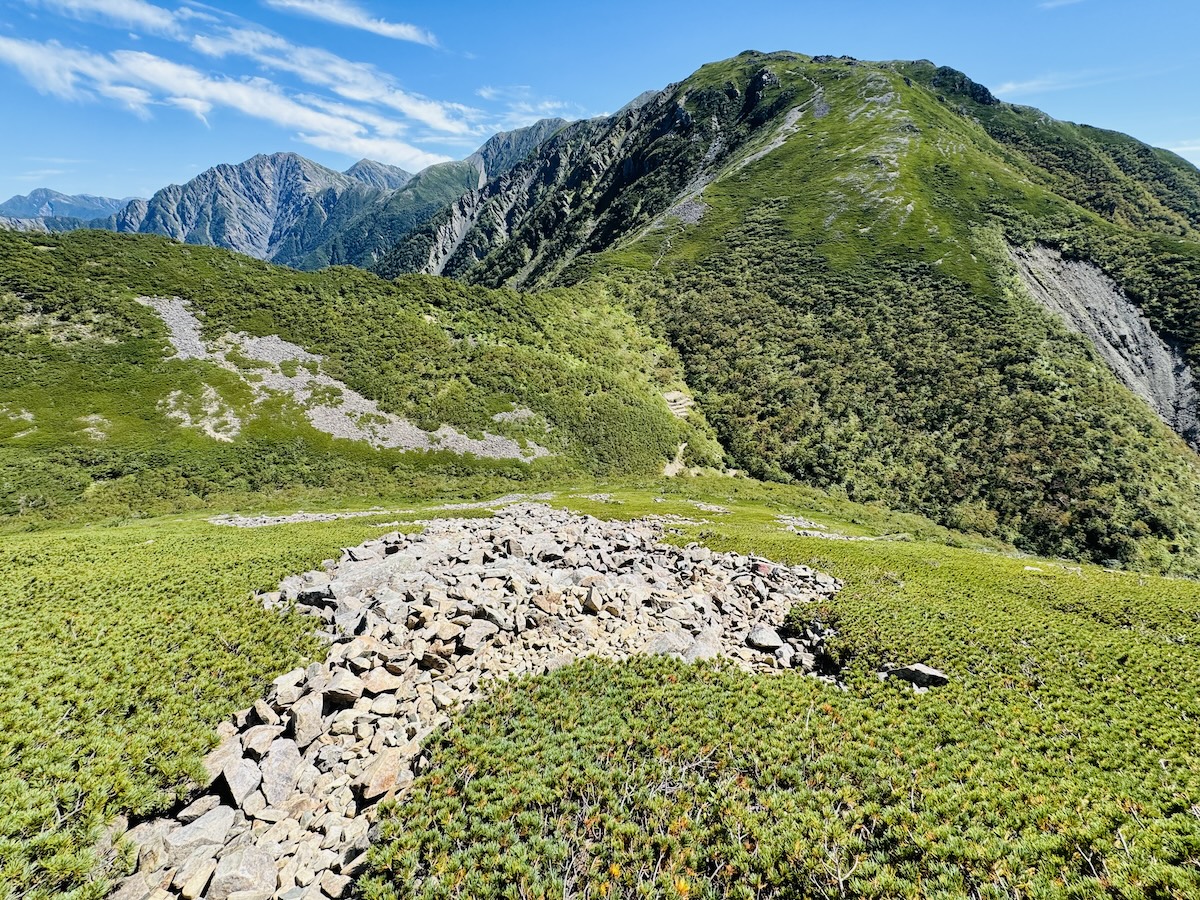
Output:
[377, 62, 797, 286]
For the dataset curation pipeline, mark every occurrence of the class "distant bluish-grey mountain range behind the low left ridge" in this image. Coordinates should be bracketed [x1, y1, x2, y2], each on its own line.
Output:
[0, 119, 566, 269]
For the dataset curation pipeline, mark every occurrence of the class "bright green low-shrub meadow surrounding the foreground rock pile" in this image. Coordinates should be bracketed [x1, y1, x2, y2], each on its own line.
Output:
[0, 478, 1200, 899]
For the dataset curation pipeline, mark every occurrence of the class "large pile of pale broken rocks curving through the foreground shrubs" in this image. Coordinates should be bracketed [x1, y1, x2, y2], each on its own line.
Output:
[114, 504, 840, 900]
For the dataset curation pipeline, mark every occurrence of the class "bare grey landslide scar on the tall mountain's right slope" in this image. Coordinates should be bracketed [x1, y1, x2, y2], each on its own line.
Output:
[1013, 246, 1200, 449]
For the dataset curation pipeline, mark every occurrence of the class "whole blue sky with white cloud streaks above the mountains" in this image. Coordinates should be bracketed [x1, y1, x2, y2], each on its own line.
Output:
[0, 0, 1200, 199]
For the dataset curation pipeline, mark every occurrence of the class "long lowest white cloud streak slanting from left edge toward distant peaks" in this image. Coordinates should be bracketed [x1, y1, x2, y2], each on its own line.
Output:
[0, 37, 446, 169]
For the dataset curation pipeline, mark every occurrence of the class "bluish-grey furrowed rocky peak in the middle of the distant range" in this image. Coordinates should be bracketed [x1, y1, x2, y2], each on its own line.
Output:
[128, 154, 377, 259]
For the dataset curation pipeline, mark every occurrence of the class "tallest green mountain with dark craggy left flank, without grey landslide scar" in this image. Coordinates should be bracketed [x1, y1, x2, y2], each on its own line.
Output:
[379, 53, 1200, 569]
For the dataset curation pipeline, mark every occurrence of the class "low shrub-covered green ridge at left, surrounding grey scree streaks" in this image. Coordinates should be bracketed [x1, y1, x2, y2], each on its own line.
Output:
[0, 226, 718, 518]
